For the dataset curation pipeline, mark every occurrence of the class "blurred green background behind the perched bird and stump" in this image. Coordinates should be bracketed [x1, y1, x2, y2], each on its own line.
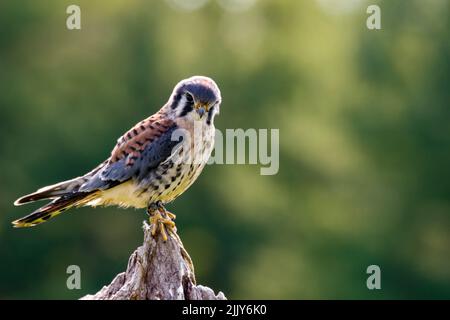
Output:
[0, 0, 450, 299]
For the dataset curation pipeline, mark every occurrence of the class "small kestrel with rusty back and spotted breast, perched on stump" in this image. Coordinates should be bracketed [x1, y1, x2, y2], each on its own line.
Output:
[13, 76, 221, 239]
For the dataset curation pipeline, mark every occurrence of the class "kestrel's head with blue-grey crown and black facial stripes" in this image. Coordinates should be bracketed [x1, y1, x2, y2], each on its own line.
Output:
[169, 76, 222, 125]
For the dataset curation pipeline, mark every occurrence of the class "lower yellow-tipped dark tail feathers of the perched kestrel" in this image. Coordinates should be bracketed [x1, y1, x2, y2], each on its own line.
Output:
[12, 192, 95, 228]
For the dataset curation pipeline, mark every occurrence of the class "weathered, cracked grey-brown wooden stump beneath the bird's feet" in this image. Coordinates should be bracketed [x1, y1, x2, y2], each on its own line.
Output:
[81, 223, 226, 300]
